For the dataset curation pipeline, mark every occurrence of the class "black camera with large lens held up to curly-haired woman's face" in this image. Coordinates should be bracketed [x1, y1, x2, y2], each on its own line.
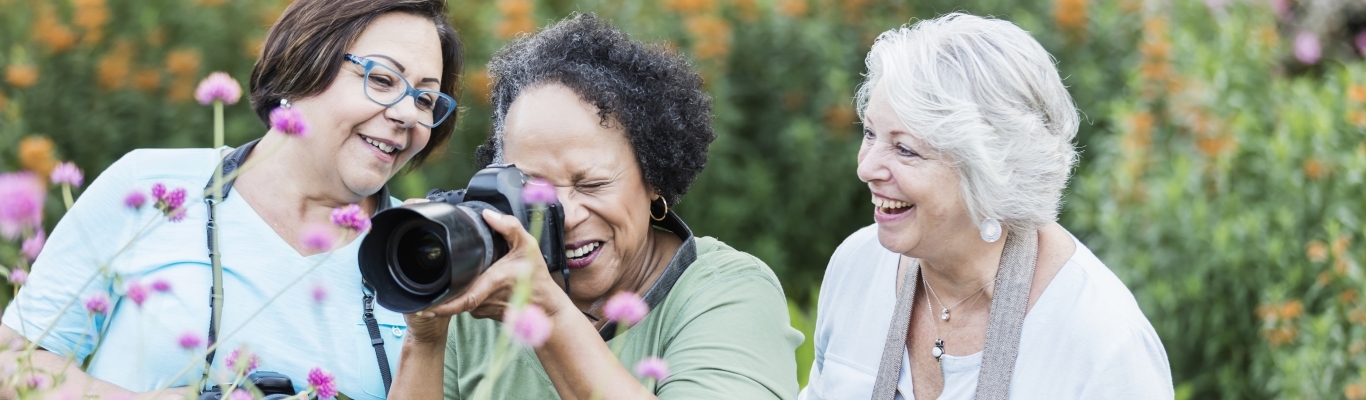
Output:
[358, 164, 567, 313]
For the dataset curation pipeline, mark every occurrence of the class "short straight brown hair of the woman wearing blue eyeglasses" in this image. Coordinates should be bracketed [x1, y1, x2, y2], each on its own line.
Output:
[250, 0, 464, 169]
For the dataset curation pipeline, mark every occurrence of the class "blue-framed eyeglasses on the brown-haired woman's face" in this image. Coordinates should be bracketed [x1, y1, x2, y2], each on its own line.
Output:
[346, 53, 455, 128]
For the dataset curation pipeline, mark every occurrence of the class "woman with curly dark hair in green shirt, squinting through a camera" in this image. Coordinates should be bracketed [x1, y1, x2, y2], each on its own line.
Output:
[393, 15, 802, 399]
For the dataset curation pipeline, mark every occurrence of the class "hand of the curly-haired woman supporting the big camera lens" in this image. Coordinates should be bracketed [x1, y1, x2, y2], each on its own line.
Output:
[419, 210, 572, 321]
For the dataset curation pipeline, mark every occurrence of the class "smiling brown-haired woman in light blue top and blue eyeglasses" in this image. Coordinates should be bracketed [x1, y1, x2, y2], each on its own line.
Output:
[0, 0, 463, 399]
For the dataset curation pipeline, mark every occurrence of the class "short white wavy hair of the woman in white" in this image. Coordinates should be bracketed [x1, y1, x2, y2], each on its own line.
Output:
[856, 12, 1081, 229]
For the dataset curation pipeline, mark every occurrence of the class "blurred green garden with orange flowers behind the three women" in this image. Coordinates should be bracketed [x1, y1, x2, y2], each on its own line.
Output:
[0, 0, 1366, 399]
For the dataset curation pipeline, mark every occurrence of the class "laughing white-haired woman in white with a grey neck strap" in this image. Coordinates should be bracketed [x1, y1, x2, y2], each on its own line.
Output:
[802, 14, 1173, 399]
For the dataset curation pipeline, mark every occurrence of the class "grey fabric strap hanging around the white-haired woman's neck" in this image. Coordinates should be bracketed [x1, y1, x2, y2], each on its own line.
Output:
[873, 232, 1038, 400]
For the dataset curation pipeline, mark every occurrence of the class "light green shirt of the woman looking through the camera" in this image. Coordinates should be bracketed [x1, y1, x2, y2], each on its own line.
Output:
[445, 238, 802, 399]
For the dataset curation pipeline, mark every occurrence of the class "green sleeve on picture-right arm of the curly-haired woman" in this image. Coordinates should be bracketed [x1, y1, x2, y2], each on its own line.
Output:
[656, 255, 802, 399]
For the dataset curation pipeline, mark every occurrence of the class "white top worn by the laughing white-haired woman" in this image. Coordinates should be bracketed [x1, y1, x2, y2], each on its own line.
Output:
[799, 225, 1175, 400]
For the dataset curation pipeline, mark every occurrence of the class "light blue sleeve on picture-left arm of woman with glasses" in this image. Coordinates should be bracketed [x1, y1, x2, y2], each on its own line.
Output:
[3, 152, 158, 359]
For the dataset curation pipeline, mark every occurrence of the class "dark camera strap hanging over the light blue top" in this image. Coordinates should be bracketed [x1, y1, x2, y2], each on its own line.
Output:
[204, 139, 393, 393]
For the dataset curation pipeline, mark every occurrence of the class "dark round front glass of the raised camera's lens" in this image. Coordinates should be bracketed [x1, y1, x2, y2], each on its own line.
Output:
[389, 220, 451, 295]
